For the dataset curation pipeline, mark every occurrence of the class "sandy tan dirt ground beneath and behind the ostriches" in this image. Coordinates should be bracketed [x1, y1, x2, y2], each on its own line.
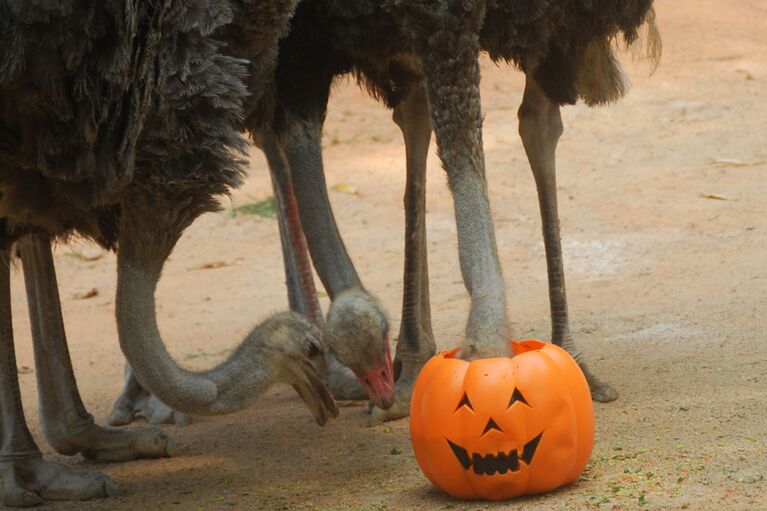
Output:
[7, 0, 767, 511]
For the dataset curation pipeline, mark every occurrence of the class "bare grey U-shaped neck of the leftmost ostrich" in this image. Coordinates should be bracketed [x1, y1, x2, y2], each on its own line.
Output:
[116, 255, 273, 415]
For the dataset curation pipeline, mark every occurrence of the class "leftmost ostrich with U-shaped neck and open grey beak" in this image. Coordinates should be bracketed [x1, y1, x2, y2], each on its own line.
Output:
[0, 0, 338, 506]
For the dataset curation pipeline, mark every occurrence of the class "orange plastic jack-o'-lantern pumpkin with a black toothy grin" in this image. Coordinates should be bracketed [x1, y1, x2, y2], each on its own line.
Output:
[410, 340, 594, 500]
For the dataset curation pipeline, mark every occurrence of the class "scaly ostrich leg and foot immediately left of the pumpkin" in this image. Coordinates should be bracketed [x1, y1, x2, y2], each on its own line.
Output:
[370, 87, 436, 424]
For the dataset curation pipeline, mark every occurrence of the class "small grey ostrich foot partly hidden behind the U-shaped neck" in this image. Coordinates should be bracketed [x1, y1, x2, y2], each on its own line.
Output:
[107, 362, 190, 426]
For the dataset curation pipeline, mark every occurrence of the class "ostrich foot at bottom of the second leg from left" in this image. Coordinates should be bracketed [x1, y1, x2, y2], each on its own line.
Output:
[47, 422, 181, 463]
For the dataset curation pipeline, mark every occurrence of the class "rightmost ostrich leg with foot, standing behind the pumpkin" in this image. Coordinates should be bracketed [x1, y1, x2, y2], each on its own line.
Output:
[519, 76, 618, 402]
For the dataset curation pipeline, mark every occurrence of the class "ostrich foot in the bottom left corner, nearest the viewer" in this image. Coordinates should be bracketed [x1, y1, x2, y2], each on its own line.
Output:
[0, 458, 123, 507]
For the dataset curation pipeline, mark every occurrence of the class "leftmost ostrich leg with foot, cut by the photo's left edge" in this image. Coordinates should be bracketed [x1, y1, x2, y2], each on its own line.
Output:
[0, 240, 122, 507]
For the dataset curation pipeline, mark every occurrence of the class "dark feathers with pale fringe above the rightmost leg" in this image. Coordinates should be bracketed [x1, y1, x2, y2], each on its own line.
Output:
[481, 0, 661, 105]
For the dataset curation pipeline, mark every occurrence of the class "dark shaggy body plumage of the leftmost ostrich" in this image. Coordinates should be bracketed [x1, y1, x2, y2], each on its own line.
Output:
[0, 0, 245, 245]
